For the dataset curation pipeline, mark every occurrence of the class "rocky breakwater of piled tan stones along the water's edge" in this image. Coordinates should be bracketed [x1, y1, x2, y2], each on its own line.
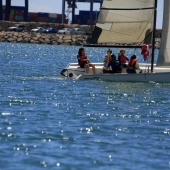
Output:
[0, 31, 87, 45]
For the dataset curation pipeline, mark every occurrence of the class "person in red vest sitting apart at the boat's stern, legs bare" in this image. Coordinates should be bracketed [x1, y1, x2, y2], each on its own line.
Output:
[77, 48, 96, 74]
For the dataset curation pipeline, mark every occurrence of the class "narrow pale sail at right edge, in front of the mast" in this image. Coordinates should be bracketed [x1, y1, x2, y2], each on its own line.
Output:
[157, 0, 170, 66]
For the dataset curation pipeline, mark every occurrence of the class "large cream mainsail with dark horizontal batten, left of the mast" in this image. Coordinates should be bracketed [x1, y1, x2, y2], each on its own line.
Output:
[96, 0, 155, 43]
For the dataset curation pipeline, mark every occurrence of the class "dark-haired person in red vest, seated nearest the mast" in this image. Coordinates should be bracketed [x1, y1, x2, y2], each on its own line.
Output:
[126, 55, 139, 73]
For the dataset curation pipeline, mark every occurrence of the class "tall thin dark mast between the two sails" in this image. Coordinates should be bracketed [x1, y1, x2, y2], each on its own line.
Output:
[151, 0, 157, 72]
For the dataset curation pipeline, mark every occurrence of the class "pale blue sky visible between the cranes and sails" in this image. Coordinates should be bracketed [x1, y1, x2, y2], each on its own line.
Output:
[2, 0, 164, 29]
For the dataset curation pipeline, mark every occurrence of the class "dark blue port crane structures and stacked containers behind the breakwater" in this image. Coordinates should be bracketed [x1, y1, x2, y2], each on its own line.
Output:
[0, 0, 103, 25]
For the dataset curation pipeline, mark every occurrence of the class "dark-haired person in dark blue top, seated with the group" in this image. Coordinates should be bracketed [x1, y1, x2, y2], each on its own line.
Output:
[103, 54, 121, 73]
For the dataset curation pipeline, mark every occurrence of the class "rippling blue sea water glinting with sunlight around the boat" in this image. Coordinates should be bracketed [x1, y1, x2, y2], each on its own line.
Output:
[0, 43, 170, 170]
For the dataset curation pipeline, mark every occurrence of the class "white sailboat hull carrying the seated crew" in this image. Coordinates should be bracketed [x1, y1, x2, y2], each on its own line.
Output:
[61, 63, 170, 83]
